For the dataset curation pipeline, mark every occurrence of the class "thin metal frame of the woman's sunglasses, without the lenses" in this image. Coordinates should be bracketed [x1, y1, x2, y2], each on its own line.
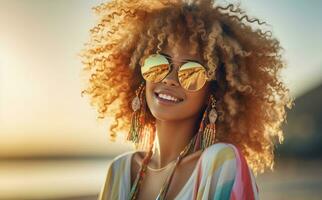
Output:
[141, 53, 215, 92]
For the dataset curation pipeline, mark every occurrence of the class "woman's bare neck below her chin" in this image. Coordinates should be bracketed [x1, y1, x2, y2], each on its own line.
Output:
[150, 118, 197, 168]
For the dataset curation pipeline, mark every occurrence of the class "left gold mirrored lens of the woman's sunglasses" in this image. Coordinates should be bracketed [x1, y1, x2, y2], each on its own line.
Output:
[141, 54, 170, 83]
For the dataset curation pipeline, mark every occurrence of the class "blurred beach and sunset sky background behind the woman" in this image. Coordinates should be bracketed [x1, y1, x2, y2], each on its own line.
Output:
[0, 0, 322, 200]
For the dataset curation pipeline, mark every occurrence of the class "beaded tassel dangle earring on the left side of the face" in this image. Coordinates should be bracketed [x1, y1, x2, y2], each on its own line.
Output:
[127, 83, 146, 148]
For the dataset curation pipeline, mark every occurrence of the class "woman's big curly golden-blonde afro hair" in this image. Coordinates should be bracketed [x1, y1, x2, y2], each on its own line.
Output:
[80, 0, 292, 174]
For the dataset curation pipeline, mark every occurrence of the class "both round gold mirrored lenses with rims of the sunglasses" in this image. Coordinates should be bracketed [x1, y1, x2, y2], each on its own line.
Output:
[141, 54, 208, 92]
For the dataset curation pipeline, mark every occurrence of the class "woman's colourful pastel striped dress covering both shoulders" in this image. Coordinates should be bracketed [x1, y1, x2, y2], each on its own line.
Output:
[98, 142, 259, 200]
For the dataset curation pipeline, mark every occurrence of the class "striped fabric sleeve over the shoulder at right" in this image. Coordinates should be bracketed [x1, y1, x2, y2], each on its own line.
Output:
[194, 143, 259, 200]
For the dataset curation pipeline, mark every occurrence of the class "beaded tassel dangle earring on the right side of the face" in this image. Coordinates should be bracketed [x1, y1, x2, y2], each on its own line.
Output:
[194, 95, 217, 151]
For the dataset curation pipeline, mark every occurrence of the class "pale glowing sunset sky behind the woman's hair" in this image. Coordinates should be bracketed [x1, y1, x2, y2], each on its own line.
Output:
[0, 0, 322, 158]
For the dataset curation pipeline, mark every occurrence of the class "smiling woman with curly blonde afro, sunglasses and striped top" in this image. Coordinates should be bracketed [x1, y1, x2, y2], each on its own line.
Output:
[82, 0, 291, 200]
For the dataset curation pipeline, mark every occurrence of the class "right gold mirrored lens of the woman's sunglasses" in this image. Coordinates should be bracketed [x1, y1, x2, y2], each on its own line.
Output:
[178, 62, 206, 91]
